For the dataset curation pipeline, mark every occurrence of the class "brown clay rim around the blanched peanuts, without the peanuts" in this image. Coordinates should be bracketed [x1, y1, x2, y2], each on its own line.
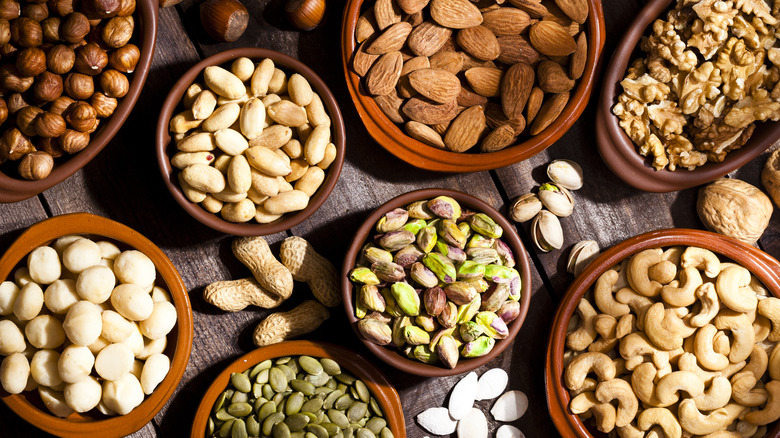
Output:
[155, 47, 346, 236]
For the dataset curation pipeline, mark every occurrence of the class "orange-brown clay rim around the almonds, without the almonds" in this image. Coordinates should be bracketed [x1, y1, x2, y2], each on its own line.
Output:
[341, 0, 606, 173]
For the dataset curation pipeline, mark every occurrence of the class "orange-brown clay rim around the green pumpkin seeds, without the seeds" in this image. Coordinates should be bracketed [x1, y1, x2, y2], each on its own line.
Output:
[190, 340, 406, 438]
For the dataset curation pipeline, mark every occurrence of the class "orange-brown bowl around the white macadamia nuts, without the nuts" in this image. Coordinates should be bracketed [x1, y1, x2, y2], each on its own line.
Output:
[0, 213, 192, 438]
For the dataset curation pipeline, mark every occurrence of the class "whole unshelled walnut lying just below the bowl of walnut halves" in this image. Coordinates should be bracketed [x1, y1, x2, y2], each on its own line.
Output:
[696, 178, 773, 245]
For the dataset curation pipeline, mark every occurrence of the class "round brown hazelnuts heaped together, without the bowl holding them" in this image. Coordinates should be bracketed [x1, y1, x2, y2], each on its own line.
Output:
[0, 0, 140, 180]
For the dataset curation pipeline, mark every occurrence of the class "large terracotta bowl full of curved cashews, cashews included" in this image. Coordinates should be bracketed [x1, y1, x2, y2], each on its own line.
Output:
[545, 229, 780, 438]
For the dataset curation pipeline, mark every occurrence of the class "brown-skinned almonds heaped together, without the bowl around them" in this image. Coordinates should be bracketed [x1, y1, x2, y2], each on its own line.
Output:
[352, 0, 588, 152]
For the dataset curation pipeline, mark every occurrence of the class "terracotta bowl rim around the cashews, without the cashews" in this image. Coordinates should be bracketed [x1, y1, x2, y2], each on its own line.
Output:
[545, 229, 780, 438]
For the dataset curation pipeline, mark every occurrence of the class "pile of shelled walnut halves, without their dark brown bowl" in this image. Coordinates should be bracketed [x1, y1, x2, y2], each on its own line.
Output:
[612, 0, 780, 170]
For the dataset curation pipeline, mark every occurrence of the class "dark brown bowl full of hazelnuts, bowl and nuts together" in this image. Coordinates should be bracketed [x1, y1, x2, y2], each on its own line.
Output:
[0, 0, 157, 202]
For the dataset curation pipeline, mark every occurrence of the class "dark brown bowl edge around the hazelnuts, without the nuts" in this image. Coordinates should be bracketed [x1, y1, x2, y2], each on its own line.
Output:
[0, 0, 159, 202]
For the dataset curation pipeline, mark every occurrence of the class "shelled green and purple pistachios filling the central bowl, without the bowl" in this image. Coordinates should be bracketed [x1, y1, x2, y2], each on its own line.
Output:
[349, 196, 521, 368]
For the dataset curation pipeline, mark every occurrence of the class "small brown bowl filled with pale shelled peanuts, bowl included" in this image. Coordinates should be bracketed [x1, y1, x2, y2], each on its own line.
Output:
[156, 48, 345, 236]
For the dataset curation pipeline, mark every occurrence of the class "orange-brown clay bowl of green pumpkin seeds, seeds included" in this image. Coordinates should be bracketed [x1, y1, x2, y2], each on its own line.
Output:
[191, 341, 406, 438]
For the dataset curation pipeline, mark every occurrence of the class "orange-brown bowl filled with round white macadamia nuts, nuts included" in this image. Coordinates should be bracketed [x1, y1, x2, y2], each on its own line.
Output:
[0, 213, 193, 437]
